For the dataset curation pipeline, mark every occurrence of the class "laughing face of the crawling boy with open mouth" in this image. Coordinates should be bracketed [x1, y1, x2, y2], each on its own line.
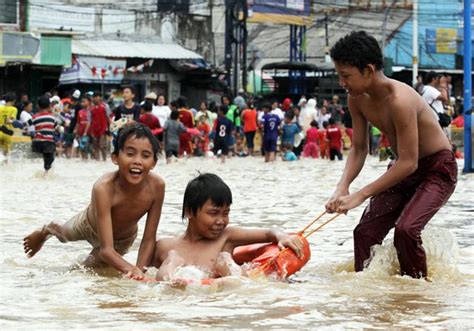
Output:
[112, 136, 156, 185]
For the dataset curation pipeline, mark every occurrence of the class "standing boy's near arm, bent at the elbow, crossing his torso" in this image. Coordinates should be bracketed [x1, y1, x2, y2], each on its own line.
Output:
[336, 100, 418, 213]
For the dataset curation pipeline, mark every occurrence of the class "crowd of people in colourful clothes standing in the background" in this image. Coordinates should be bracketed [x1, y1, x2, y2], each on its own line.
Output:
[0, 72, 463, 170]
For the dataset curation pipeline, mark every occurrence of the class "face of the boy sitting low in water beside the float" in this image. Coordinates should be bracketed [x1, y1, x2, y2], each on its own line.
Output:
[188, 199, 230, 239]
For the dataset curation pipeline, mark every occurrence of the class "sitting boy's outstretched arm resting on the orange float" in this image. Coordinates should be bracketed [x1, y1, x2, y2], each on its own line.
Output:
[226, 227, 303, 257]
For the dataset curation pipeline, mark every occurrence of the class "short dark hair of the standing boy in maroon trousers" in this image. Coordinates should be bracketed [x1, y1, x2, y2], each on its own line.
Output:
[331, 31, 383, 72]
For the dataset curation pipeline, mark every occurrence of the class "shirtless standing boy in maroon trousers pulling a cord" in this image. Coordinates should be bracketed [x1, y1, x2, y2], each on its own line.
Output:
[326, 31, 457, 278]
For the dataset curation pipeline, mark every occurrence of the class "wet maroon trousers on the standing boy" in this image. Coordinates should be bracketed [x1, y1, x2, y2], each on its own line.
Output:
[354, 150, 458, 278]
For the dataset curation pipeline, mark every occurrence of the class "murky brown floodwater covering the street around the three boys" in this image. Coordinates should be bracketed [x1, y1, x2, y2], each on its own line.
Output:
[0, 157, 474, 330]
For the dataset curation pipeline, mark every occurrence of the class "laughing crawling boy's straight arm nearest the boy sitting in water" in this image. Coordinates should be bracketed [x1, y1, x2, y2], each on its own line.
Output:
[137, 178, 165, 271]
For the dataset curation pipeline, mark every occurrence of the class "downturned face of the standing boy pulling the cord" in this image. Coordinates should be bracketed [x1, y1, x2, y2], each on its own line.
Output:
[334, 62, 370, 97]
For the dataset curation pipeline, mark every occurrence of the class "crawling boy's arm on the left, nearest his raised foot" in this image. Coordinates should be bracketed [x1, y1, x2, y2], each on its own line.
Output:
[92, 184, 134, 273]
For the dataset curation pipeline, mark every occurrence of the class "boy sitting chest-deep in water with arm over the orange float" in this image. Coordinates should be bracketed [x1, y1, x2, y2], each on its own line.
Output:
[152, 173, 303, 281]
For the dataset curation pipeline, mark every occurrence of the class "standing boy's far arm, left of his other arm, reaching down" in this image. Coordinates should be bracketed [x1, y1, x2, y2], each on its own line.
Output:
[326, 98, 368, 213]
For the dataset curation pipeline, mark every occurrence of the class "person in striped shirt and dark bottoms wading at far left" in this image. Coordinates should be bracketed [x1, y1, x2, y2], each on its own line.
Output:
[32, 96, 58, 174]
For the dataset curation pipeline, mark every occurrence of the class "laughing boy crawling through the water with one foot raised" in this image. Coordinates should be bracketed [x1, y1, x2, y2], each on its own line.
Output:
[23, 124, 165, 278]
